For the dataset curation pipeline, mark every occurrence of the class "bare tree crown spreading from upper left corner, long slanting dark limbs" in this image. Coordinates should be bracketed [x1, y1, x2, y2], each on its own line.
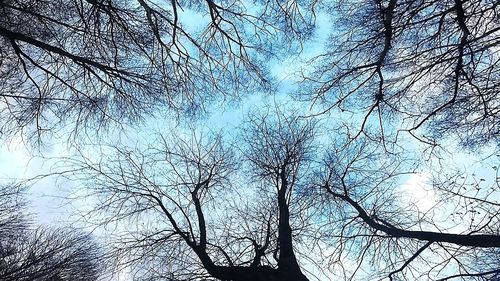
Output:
[0, 0, 311, 139]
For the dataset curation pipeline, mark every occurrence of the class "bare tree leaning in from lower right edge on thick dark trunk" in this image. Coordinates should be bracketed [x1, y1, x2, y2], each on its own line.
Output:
[313, 133, 500, 280]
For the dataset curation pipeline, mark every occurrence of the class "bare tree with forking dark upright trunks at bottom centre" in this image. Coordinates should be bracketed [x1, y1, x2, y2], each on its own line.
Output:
[65, 109, 314, 280]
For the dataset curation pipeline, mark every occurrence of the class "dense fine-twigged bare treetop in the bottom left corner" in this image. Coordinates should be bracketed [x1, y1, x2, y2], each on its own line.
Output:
[0, 185, 105, 281]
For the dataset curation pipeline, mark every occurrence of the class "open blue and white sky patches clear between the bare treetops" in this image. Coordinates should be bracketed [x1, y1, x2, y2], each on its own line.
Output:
[0, 1, 500, 280]
